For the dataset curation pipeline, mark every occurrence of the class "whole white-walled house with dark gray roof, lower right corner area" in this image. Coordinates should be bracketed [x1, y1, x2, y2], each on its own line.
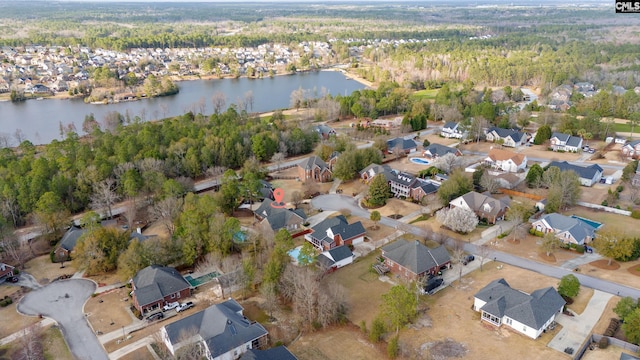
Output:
[473, 279, 566, 339]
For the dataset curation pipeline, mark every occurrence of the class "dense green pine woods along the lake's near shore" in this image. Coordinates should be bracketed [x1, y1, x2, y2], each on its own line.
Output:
[0, 106, 318, 226]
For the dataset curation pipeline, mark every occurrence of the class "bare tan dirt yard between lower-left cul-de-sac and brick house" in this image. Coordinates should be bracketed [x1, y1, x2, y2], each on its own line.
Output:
[84, 288, 133, 334]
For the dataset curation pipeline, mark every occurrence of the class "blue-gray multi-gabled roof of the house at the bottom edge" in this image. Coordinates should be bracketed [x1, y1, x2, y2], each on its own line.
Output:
[164, 299, 267, 358]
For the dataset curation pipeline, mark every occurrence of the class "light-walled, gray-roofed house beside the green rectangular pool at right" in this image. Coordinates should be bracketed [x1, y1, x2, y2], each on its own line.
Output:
[531, 213, 597, 245]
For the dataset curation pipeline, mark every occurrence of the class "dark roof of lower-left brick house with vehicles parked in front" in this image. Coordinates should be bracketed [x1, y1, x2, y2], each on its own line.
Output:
[133, 265, 191, 306]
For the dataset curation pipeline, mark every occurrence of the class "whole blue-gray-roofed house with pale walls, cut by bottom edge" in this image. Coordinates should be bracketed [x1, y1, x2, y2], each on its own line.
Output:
[160, 299, 268, 360]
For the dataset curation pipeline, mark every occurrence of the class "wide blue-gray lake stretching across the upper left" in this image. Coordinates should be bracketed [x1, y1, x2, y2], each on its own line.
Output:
[0, 71, 365, 145]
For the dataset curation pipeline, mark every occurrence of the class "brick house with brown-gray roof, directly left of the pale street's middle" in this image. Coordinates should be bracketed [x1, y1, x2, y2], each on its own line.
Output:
[382, 239, 451, 281]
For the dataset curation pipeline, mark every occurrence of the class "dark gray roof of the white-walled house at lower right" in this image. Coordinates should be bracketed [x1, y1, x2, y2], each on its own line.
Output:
[474, 279, 565, 329]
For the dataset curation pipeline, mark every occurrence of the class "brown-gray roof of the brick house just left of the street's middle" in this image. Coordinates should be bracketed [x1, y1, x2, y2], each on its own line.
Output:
[382, 239, 451, 275]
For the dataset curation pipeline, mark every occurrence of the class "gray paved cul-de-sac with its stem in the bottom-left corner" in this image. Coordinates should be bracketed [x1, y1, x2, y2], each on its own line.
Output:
[18, 279, 108, 360]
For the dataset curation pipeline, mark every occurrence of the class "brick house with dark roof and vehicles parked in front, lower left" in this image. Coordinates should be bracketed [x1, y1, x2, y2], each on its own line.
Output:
[131, 265, 191, 314]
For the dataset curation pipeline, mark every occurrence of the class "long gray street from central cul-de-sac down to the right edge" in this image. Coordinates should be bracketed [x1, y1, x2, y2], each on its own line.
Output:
[311, 194, 640, 299]
